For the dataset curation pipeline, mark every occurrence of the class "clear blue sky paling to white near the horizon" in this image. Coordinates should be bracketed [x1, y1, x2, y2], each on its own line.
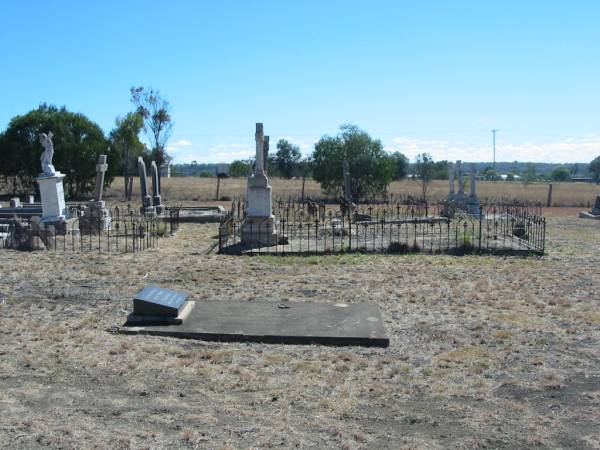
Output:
[0, 0, 600, 162]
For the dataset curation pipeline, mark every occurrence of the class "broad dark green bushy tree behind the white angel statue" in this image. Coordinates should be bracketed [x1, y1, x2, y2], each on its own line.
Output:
[0, 104, 111, 197]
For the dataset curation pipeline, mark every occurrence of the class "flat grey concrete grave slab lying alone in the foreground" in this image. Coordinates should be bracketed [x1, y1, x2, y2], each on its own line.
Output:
[119, 296, 389, 347]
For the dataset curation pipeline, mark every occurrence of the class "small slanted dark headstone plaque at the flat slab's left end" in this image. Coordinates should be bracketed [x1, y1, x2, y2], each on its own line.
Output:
[133, 285, 187, 317]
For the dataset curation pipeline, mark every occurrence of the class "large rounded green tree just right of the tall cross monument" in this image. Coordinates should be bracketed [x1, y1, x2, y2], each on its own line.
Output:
[312, 125, 394, 198]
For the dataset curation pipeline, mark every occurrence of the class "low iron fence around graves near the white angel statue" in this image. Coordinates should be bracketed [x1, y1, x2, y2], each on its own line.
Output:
[0, 205, 179, 253]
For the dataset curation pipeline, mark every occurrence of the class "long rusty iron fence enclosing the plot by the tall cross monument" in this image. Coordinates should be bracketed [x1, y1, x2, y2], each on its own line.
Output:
[219, 199, 546, 255]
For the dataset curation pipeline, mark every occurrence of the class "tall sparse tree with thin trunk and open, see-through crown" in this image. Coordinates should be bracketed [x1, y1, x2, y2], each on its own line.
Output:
[130, 86, 173, 167]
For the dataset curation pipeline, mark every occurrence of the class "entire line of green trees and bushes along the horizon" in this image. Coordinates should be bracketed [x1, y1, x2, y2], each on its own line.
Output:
[0, 100, 600, 202]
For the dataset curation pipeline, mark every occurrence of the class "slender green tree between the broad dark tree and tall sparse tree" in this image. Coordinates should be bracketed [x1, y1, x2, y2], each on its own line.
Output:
[108, 112, 147, 200]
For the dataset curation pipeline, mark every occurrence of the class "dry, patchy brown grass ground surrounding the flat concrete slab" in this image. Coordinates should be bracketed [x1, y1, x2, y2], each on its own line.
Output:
[0, 209, 600, 449]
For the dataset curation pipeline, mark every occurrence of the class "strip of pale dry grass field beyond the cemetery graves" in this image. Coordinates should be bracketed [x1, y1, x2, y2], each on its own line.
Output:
[106, 177, 600, 207]
